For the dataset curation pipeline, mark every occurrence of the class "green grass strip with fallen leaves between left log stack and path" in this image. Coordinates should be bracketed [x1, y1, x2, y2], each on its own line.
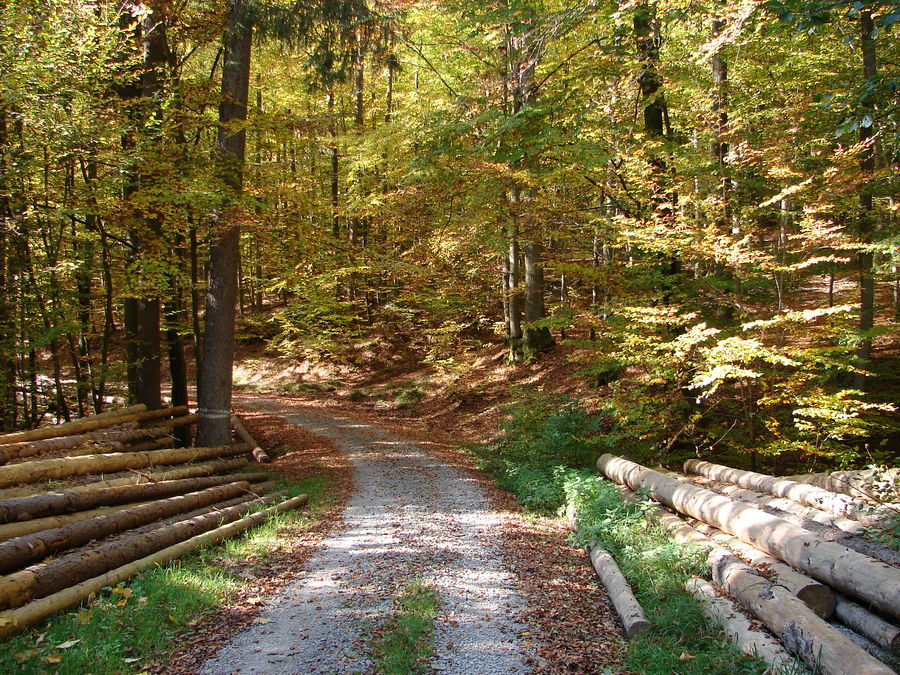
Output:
[0, 476, 330, 675]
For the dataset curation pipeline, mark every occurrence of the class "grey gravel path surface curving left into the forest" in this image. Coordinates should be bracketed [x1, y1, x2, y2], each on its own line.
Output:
[201, 397, 530, 675]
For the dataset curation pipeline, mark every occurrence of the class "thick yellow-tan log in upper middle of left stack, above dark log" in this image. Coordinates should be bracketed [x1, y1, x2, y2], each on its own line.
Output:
[0, 444, 250, 487]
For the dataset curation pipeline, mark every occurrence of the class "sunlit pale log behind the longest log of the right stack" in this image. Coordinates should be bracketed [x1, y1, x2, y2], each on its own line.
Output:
[684, 459, 887, 525]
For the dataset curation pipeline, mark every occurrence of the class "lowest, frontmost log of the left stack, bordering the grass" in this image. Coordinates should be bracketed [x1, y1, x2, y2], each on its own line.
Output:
[0, 495, 307, 636]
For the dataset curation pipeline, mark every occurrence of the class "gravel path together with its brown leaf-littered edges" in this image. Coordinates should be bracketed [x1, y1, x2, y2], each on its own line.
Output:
[158, 378, 621, 673]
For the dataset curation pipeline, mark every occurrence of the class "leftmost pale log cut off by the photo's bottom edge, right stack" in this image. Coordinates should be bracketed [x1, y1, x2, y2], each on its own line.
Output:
[684, 577, 795, 672]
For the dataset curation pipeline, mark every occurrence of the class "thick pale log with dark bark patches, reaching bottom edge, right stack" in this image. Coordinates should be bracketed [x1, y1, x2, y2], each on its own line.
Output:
[709, 548, 893, 675]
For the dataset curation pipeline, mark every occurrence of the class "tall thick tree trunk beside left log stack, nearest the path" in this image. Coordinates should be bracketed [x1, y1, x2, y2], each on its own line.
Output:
[197, 0, 253, 445]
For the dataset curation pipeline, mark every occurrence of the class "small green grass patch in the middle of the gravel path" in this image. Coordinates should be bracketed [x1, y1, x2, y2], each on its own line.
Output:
[372, 581, 440, 675]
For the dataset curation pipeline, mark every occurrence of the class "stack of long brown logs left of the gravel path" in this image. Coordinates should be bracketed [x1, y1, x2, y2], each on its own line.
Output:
[0, 406, 306, 636]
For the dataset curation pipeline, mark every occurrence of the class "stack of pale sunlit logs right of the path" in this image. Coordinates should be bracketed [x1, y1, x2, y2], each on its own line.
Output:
[597, 454, 900, 674]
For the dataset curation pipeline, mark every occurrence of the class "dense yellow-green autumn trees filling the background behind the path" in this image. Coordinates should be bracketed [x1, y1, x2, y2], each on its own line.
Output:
[0, 0, 900, 468]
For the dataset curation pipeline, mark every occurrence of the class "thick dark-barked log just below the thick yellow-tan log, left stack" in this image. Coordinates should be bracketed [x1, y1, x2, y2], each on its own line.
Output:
[0, 473, 265, 523]
